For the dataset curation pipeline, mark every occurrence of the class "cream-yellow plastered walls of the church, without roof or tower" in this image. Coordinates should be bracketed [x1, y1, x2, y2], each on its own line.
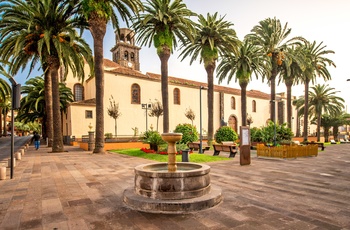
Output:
[63, 61, 314, 137]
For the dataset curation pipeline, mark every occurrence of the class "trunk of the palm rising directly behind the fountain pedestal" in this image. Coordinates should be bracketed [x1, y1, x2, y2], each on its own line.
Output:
[158, 45, 170, 133]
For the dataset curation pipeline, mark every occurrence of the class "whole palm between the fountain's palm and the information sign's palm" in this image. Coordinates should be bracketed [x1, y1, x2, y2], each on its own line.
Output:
[180, 13, 240, 142]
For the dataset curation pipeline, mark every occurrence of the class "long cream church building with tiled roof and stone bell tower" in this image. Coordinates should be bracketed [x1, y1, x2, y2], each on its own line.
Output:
[62, 29, 296, 138]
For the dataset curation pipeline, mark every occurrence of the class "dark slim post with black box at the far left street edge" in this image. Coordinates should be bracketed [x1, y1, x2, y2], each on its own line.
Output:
[9, 77, 21, 179]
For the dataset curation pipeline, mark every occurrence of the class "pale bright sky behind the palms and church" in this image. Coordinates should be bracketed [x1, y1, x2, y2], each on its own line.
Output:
[11, 0, 350, 112]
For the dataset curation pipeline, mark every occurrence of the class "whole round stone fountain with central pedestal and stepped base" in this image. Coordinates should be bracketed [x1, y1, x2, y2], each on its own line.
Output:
[124, 133, 222, 213]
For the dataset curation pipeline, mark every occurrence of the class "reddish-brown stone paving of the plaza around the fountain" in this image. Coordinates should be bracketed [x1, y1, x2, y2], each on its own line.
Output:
[0, 145, 350, 230]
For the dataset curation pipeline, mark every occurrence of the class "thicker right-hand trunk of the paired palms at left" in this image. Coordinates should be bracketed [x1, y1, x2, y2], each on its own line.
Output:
[48, 56, 64, 153]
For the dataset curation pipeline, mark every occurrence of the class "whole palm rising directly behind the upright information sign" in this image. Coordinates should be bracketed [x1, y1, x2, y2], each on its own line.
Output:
[217, 40, 271, 126]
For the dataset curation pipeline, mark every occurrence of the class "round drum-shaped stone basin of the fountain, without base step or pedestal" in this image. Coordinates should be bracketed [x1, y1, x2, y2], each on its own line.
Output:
[135, 163, 210, 200]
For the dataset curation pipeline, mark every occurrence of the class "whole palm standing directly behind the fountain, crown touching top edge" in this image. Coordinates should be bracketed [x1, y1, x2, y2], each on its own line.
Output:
[133, 0, 195, 133]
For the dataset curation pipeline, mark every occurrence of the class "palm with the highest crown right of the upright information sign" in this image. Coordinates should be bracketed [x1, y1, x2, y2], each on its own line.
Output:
[246, 18, 291, 122]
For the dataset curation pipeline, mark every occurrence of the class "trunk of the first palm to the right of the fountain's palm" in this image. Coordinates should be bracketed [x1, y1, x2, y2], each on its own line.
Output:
[205, 62, 215, 144]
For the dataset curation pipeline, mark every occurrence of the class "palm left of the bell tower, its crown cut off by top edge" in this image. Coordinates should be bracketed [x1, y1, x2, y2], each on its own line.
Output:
[81, 0, 143, 153]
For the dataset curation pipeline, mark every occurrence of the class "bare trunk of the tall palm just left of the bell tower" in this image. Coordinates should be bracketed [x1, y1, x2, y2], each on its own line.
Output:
[89, 15, 107, 153]
